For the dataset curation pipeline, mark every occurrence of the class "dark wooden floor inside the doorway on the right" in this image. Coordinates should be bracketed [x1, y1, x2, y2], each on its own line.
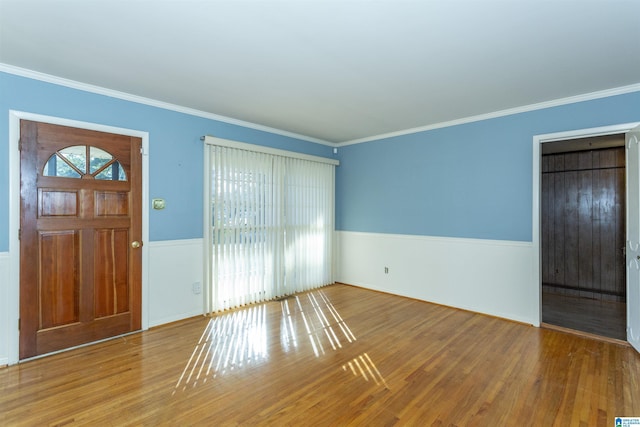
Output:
[542, 292, 627, 341]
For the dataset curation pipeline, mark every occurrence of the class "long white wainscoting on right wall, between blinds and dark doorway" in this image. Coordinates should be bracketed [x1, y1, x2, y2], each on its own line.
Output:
[335, 231, 540, 326]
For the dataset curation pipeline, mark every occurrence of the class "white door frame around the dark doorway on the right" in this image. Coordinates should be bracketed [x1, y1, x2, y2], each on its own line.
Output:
[532, 122, 640, 326]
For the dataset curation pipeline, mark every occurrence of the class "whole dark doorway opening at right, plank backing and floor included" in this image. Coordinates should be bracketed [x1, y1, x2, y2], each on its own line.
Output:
[540, 134, 627, 340]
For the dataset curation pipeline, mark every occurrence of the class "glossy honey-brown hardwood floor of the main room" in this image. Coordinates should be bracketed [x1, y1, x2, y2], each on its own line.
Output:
[0, 285, 640, 426]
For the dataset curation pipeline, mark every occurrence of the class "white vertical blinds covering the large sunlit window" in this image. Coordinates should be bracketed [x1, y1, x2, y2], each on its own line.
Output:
[204, 137, 337, 312]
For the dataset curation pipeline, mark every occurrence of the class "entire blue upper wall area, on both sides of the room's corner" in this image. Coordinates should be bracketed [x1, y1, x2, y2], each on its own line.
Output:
[0, 72, 640, 252]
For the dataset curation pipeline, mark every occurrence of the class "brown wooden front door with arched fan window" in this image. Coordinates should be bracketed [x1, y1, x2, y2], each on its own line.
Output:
[20, 120, 142, 359]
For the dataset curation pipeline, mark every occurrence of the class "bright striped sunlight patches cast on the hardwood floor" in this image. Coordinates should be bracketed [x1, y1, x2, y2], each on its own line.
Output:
[173, 290, 387, 394]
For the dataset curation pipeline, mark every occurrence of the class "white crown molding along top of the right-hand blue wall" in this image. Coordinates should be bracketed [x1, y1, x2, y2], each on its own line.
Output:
[335, 83, 640, 147]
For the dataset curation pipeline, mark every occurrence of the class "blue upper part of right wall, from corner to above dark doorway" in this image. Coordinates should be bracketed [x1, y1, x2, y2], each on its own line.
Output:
[336, 92, 640, 242]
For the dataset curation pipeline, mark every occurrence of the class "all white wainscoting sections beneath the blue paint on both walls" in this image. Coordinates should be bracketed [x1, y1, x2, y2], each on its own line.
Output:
[0, 236, 540, 366]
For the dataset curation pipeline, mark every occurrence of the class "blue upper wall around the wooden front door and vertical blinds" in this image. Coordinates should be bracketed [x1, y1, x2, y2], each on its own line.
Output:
[0, 72, 333, 252]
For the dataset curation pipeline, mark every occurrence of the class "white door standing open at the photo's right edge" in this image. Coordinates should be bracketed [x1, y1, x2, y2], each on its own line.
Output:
[626, 127, 640, 351]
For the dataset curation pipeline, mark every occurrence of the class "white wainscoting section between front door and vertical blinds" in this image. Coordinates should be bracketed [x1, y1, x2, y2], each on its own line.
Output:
[149, 239, 203, 327]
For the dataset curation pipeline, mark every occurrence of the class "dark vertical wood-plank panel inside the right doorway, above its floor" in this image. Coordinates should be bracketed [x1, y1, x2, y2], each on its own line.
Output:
[541, 147, 626, 302]
